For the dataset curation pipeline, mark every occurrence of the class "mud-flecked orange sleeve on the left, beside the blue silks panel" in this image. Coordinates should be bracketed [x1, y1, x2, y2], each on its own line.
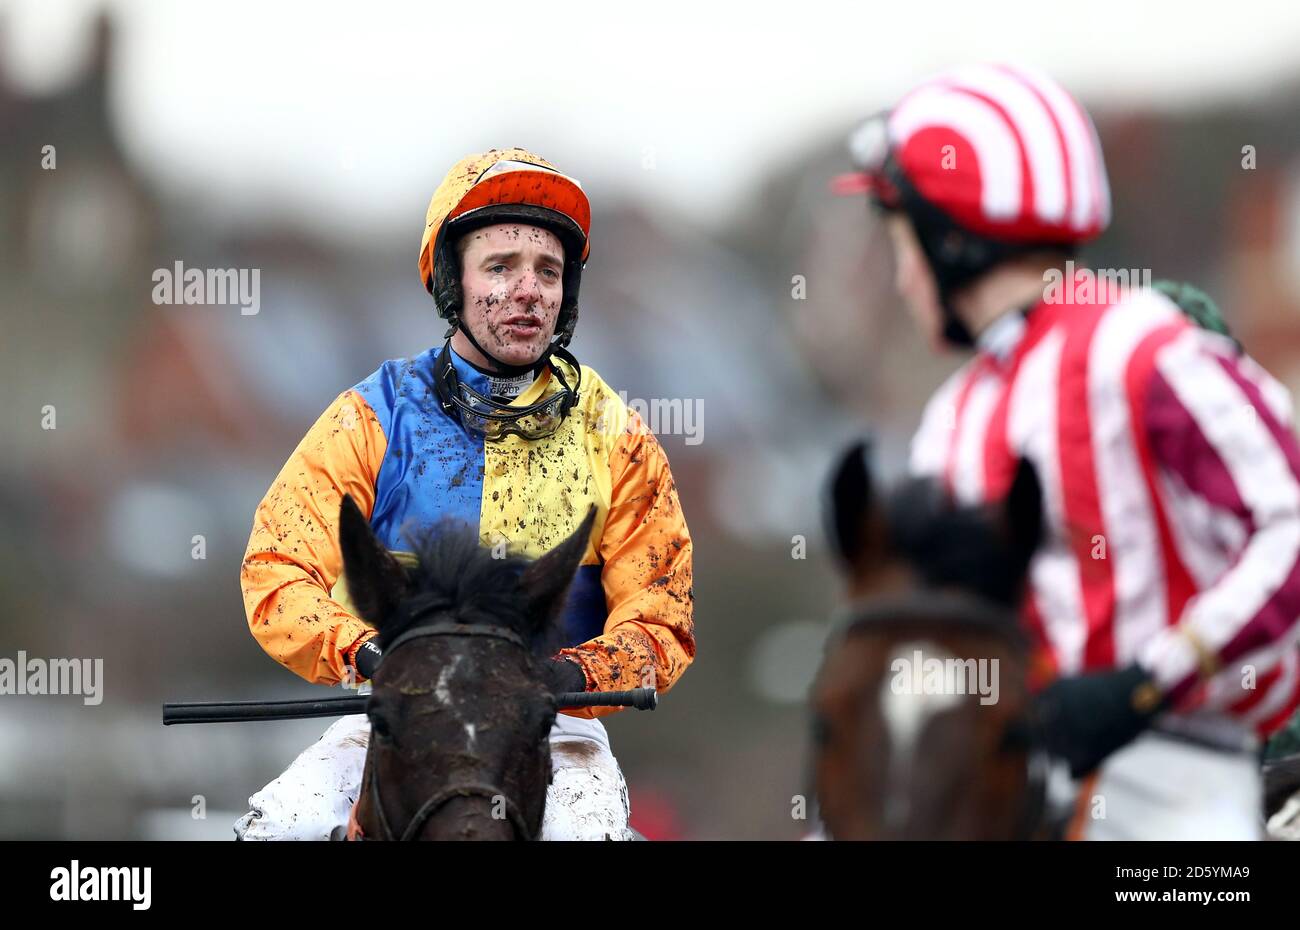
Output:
[239, 390, 387, 684]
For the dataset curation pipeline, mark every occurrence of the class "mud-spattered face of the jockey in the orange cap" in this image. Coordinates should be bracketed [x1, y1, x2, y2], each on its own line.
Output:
[451, 222, 564, 368]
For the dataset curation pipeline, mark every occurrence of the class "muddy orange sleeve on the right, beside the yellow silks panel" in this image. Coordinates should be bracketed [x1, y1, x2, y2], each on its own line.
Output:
[560, 411, 696, 717]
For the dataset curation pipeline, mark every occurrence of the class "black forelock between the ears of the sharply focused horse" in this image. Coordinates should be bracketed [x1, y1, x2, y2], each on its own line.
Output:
[380, 518, 545, 649]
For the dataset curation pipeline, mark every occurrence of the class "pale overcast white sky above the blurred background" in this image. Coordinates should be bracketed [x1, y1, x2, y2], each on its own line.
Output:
[0, 0, 1300, 236]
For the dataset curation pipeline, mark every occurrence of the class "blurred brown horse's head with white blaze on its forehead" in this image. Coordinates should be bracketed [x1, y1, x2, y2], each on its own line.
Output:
[813, 445, 1041, 839]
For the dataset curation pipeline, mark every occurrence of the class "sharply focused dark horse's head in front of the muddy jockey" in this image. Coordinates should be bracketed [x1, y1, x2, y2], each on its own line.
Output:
[339, 497, 595, 840]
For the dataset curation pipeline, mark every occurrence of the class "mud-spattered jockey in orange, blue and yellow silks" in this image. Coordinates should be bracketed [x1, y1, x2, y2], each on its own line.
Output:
[235, 148, 696, 839]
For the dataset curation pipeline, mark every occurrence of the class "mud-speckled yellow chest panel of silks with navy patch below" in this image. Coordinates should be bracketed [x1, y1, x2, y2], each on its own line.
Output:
[478, 359, 628, 643]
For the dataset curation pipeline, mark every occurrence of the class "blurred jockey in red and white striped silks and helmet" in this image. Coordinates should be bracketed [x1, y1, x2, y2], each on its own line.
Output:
[837, 66, 1300, 839]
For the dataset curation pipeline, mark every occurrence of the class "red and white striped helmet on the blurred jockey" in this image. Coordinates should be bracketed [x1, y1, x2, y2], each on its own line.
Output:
[836, 65, 1110, 245]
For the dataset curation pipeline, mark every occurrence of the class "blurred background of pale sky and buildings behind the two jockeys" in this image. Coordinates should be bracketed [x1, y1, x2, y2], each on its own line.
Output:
[0, 0, 1300, 839]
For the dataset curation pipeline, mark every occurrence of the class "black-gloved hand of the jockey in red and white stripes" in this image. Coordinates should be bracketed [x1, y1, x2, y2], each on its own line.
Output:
[1031, 662, 1165, 778]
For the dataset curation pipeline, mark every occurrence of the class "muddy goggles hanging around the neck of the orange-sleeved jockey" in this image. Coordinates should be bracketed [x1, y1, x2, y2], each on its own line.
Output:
[433, 339, 582, 442]
